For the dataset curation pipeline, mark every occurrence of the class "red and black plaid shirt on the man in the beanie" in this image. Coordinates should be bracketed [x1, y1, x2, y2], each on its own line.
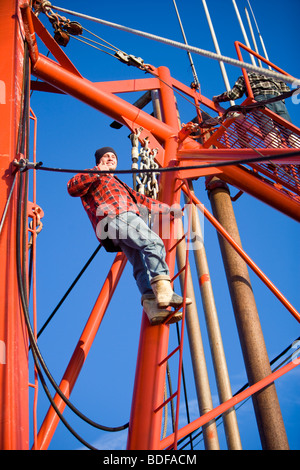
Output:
[68, 167, 170, 239]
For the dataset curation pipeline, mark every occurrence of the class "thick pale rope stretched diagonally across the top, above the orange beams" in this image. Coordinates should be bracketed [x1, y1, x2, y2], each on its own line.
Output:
[49, 2, 300, 85]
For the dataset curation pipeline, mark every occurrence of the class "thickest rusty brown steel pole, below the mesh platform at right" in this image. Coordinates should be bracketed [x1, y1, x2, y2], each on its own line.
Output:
[208, 178, 289, 450]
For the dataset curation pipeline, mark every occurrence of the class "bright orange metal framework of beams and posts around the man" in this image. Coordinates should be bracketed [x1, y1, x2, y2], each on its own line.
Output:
[0, 0, 300, 449]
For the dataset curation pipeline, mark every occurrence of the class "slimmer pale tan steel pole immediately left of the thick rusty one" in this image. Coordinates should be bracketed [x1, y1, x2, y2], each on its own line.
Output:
[189, 182, 242, 450]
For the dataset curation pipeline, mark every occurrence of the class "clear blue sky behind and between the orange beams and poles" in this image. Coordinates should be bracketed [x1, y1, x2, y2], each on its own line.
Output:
[27, 0, 300, 449]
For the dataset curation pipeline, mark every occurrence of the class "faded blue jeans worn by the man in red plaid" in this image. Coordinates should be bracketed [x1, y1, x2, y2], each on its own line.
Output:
[107, 212, 169, 295]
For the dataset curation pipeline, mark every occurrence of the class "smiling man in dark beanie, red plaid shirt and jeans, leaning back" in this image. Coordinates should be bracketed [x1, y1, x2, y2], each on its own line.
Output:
[68, 147, 191, 325]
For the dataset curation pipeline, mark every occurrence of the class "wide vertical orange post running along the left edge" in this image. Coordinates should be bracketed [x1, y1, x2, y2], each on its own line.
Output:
[0, 0, 29, 450]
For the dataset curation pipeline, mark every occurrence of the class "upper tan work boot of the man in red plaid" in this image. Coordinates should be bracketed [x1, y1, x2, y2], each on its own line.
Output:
[151, 274, 192, 308]
